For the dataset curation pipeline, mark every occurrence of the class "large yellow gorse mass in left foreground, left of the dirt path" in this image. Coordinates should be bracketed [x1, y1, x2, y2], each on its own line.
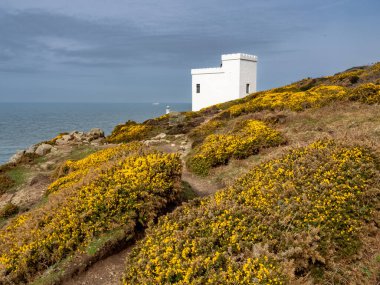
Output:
[0, 142, 181, 283]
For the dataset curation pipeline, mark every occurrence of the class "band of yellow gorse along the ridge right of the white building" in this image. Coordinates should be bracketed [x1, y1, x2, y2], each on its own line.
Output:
[216, 63, 380, 118]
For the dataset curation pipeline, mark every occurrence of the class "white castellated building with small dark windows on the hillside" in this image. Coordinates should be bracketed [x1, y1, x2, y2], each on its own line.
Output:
[191, 53, 257, 111]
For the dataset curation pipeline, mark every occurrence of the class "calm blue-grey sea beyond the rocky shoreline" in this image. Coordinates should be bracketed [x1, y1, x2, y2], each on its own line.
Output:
[0, 103, 191, 164]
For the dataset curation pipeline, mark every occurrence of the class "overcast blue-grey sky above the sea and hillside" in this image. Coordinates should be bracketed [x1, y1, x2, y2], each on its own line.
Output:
[0, 0, 380, 103]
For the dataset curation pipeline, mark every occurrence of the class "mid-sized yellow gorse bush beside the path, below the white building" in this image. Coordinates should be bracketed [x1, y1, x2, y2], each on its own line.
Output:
[187, 120, 284, 175]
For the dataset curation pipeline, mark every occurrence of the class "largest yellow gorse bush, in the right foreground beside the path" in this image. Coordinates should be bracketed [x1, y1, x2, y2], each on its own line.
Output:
[124, 141, 379, 285]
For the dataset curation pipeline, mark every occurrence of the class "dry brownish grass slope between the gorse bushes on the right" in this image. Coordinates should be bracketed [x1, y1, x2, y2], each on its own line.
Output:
[209, 102, 380, 186]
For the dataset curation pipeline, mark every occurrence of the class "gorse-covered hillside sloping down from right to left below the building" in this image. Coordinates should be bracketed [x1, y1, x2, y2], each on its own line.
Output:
[0, 63, 380, 285]
